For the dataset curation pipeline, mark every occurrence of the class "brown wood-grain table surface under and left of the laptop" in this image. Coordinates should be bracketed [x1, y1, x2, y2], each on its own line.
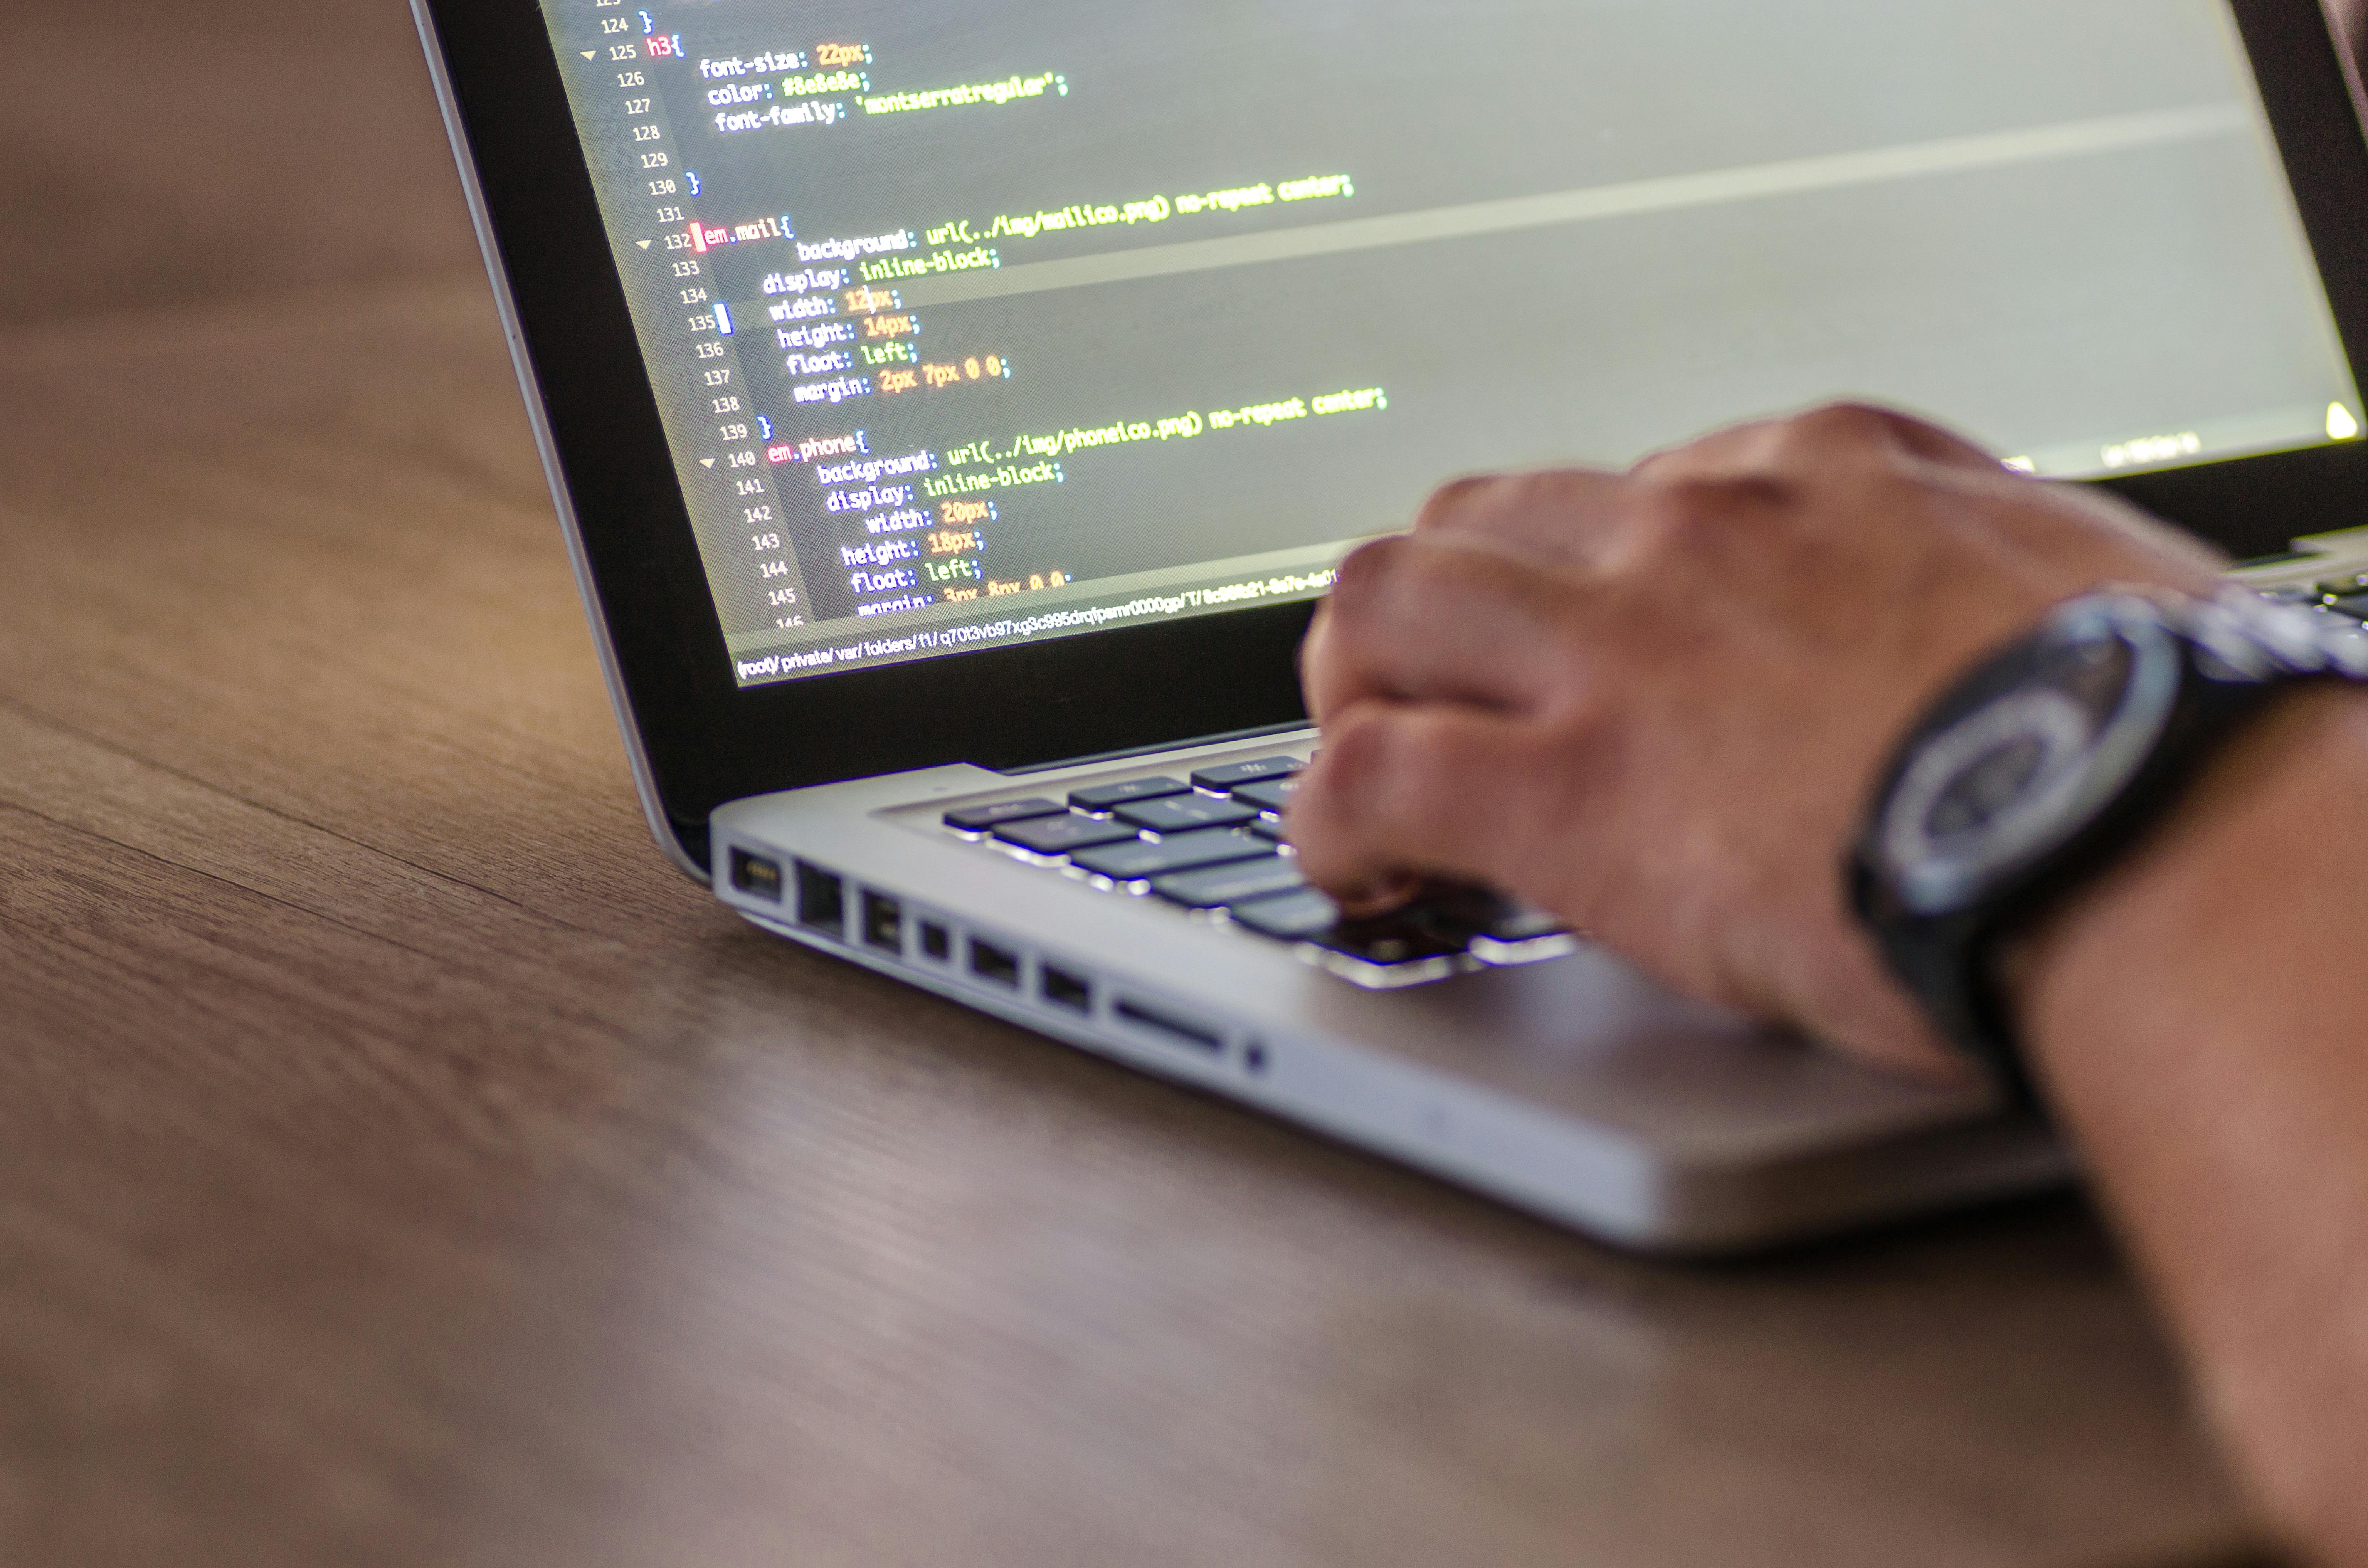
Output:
[0, 0, 2282, 1568]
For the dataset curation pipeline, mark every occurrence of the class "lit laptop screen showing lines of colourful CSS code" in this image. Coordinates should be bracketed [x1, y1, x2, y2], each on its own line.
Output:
[542, 0, 2363, 684]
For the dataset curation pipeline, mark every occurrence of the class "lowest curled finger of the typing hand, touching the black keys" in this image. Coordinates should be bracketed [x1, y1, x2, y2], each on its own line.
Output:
[1288, 699, 1542, 907]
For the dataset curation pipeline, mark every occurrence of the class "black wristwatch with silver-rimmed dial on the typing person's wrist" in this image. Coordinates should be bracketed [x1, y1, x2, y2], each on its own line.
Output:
[1847, 587, 2368, 1109]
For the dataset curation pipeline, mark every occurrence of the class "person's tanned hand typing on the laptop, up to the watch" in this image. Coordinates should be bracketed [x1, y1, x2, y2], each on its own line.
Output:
[1290, 407, 2217, 1076]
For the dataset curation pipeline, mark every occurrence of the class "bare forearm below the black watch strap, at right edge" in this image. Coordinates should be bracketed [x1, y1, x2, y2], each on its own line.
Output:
[2020, 692, 2368, 1563]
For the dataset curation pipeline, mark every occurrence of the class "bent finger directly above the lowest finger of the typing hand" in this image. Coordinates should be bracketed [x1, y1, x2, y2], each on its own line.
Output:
[1300, 533, 1589, 723]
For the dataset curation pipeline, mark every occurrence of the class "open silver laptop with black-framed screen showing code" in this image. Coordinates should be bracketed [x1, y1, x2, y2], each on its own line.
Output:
[414, 0, 2368, 1253]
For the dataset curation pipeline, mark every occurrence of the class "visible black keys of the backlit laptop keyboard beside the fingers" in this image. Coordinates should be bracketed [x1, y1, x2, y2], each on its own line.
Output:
[945, 756, 1577, 990]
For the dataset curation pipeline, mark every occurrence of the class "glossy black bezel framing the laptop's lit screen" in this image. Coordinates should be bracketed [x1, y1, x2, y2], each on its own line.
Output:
[414, 0, 2368, 862]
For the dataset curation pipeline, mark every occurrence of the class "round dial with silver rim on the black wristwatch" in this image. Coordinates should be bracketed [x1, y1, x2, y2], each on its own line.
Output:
[1873, 599, 2181, 914]
